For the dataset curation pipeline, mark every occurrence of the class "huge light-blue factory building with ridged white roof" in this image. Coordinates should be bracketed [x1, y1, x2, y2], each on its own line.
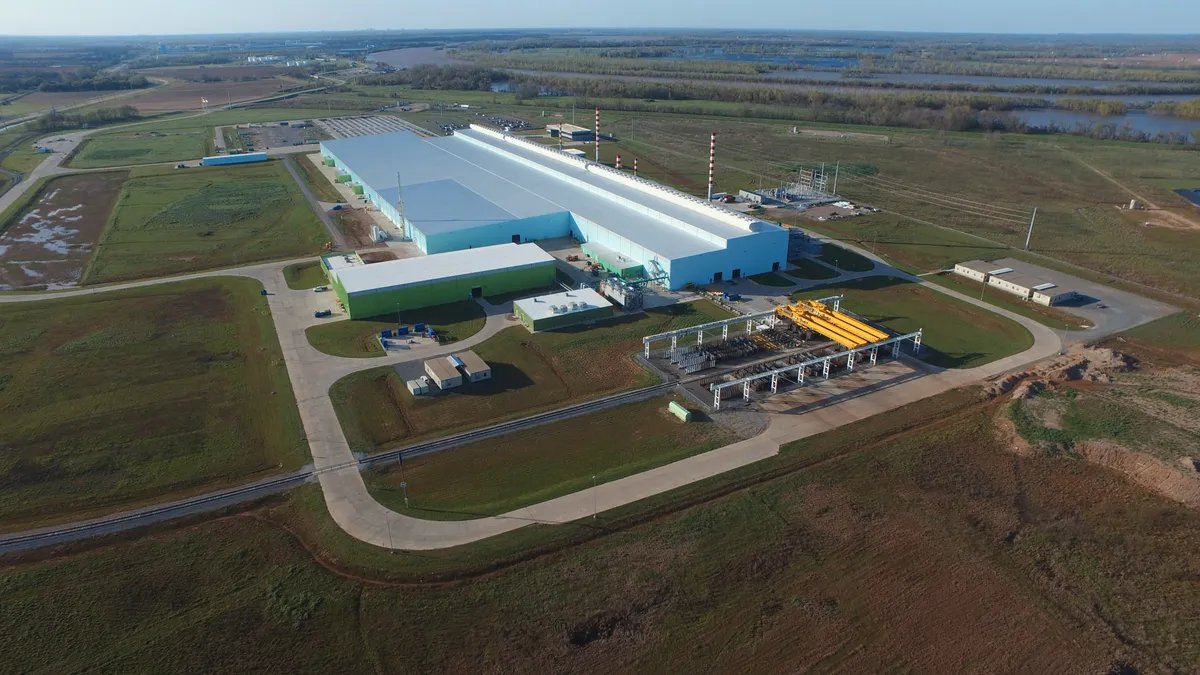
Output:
[322, 125, 788, 289]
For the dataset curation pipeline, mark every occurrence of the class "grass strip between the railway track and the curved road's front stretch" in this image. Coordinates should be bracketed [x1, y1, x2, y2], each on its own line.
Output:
[364, 398, 736, 520]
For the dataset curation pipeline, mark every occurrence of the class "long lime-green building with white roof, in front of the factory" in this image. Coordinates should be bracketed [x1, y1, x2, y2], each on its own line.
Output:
[322, 243, 554, 318]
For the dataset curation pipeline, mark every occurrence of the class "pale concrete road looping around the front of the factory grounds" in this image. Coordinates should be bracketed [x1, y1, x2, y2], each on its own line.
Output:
[0, 243, 1061, 550]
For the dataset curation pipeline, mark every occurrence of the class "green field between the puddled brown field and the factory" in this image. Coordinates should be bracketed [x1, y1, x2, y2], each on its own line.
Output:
[84, 161, 329, 283]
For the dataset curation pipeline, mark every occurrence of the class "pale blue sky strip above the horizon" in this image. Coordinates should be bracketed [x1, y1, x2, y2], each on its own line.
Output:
[7, 0, 1200, 35]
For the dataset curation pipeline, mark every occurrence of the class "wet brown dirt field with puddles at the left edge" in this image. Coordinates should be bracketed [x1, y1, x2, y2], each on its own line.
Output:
[0, 172, 128, 291]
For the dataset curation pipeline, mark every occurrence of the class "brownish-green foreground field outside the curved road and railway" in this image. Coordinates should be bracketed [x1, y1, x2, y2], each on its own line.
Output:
[9, 381, 1200, 674]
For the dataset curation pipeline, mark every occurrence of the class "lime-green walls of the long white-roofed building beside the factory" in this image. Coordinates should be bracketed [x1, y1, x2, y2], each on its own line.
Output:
[345, 261, 554, 318]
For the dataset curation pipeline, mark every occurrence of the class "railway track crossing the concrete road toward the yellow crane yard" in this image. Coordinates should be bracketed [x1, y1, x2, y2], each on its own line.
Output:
[0, 382, 679, 555]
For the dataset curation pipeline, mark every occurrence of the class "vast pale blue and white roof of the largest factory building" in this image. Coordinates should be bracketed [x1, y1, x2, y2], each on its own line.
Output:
[323, 127, 779, 259]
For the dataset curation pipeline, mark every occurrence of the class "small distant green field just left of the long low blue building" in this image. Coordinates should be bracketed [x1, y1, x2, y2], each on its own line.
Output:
[71, 126, 212, 168]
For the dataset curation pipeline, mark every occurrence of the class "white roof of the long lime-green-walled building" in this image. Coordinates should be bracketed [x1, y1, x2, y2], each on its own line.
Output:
[337, 244, 554, 295]
